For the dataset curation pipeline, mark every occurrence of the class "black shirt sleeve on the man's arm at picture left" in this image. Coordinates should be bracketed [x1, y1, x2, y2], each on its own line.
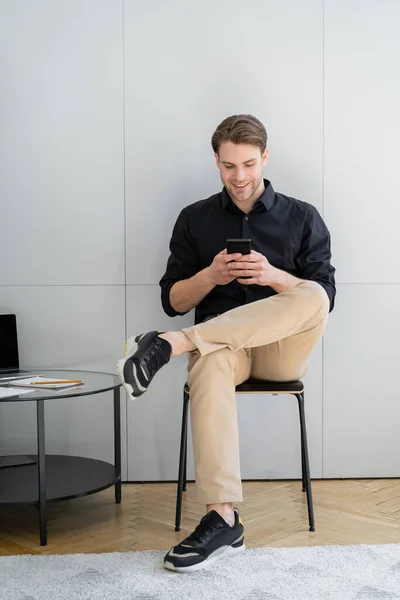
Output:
[159, 209, 199, 317]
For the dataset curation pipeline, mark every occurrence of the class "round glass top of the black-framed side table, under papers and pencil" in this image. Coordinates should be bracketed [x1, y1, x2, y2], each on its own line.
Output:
[0, 369, 121, 402]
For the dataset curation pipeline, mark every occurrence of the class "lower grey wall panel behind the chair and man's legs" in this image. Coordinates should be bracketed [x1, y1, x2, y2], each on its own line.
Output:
[128, 286, 322, 481]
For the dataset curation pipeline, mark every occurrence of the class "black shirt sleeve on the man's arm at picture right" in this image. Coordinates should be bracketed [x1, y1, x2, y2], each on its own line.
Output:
[297, 205, 336, 311]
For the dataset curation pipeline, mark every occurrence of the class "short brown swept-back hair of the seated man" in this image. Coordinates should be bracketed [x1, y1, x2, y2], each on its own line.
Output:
[211, 115, 268, 154]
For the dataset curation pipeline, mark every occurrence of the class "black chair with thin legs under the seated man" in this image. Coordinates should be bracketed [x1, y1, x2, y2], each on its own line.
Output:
[175, 379, 315, 531]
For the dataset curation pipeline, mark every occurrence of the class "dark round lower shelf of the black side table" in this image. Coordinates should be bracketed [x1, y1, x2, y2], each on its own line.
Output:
[0, 454, 120, 504]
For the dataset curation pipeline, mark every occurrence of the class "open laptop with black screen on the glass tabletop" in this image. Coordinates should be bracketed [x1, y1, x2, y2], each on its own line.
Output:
[0, 314, 35, 384]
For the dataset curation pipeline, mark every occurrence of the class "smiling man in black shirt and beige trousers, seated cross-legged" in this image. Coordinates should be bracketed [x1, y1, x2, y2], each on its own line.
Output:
[117, 115, 335, 571]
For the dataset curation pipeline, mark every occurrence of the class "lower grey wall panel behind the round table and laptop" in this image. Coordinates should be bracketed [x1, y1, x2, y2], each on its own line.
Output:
[0, 286, 126, 473]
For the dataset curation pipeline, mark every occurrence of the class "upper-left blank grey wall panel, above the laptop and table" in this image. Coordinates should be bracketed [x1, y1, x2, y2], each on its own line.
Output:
[0, 0, 125, 285]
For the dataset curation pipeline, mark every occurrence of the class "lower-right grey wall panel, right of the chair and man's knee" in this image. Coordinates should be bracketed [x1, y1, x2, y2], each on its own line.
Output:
[323, 284, 400, 477]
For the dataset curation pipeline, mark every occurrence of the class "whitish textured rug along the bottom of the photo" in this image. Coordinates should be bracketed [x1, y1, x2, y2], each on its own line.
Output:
[0, 544, 400, 600]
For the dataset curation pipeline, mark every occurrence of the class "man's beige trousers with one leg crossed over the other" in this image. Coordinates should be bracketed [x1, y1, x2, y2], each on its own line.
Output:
[183, 281, 329, 504]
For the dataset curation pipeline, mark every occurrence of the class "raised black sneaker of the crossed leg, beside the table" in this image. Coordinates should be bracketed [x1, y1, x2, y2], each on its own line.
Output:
[117, 331, 172, 400]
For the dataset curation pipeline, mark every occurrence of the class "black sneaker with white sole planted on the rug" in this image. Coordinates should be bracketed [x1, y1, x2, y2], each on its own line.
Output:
[164, 509, 246, 573]
